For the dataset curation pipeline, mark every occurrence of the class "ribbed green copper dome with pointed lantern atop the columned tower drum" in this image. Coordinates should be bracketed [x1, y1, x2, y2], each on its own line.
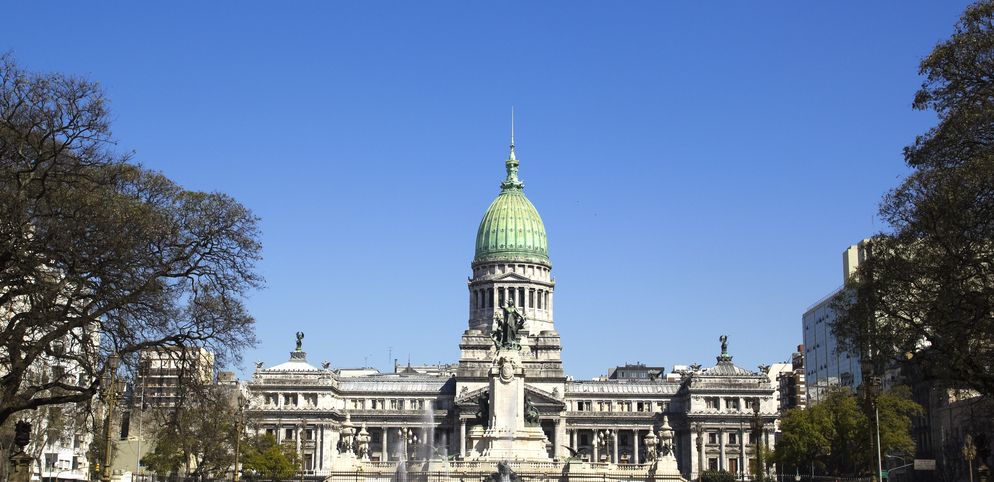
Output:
[473, 140, 549, 265]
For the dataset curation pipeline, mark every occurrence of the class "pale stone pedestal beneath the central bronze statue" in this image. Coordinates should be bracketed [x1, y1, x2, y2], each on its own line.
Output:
[479, 349, 550, 461]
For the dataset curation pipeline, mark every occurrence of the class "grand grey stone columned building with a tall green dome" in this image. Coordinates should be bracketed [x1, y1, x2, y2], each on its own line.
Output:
[246, 135, 778, 480]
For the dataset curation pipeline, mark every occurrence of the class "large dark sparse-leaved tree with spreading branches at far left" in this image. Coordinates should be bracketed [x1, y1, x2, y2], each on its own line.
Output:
[0, 54, 262, 424]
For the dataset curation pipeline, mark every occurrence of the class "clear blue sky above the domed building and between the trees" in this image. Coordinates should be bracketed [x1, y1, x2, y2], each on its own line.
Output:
[0, 1, 966, 378]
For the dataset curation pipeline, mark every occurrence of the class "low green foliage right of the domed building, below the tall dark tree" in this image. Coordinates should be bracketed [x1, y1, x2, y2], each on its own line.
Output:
[774, 387, 922, 476]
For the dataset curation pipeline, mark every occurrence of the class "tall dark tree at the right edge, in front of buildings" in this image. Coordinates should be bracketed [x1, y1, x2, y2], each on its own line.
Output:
[833, 0, 994, 396]
